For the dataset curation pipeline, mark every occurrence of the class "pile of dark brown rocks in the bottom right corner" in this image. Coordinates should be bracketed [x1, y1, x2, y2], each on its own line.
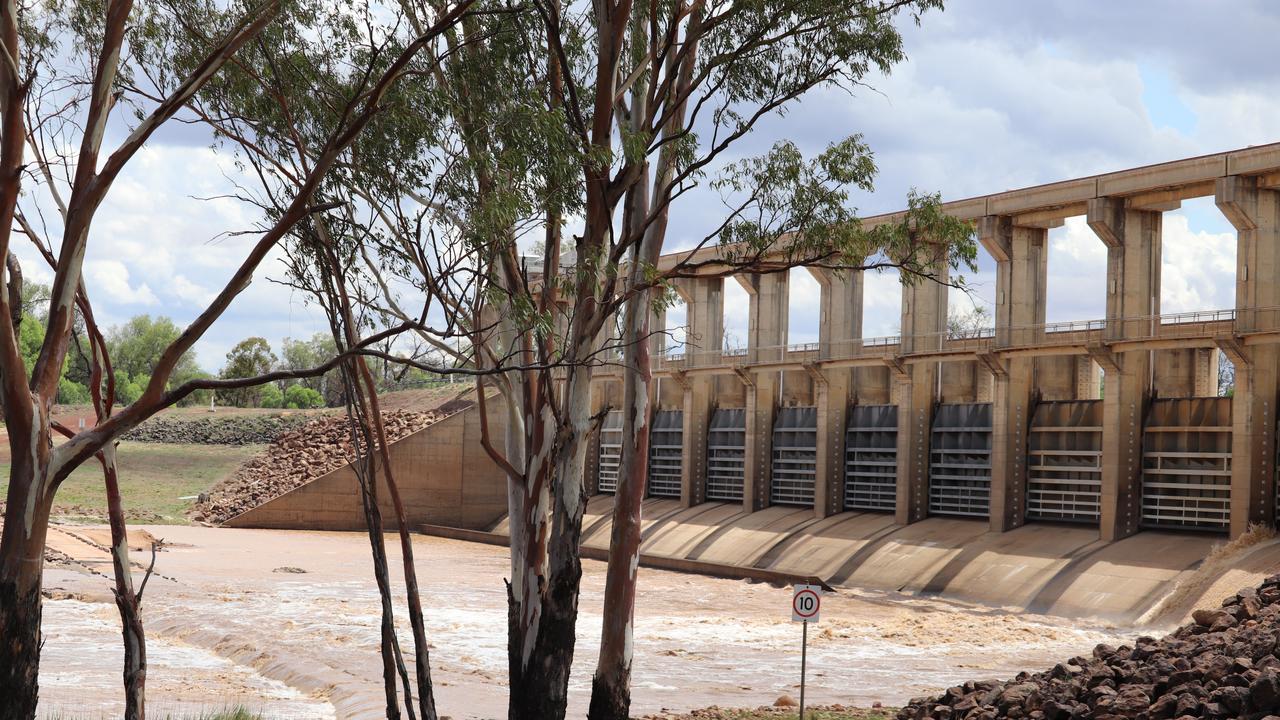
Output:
[897, 575, 1280, 720]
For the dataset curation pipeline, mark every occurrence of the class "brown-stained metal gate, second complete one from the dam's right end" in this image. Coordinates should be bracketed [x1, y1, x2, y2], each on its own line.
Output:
[1027, 400, 1102, 524]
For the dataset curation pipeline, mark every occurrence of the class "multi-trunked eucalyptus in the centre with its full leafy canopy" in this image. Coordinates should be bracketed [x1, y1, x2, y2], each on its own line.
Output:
[244, 0, 975, 719]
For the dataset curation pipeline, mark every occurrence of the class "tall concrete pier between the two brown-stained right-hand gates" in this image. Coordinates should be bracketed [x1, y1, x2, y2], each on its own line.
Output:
[1088, 197, 1161, 541]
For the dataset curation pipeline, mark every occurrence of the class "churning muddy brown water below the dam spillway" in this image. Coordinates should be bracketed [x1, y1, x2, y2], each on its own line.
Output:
[41, 527, 1137, 719]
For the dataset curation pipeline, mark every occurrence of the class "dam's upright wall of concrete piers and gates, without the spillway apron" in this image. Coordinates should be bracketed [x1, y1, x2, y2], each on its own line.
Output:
[589, 146, 1280, 541]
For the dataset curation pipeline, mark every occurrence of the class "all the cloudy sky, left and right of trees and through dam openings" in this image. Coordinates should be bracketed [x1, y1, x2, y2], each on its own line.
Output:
[19, 0, 1280, 370]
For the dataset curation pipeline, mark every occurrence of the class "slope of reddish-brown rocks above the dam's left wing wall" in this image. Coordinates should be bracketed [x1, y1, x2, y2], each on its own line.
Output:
[191, 405, 461, 524]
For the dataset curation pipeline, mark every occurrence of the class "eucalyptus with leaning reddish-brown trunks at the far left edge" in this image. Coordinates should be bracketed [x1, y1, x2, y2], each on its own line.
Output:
[0, 0, 476, 719]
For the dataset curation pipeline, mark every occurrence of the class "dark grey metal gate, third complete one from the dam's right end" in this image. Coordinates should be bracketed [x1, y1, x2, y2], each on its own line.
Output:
[929, 402, 991, 518]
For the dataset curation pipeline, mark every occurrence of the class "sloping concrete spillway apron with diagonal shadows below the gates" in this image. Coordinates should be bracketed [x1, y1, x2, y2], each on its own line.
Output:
[493, 496, 1228, 623]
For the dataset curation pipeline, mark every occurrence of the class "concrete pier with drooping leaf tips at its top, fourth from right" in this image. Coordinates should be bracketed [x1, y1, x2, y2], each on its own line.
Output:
[893, 252, 948, 525]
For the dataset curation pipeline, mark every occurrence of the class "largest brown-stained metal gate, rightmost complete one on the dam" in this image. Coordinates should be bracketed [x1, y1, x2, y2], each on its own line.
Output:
[1142, 397, 1231, 532]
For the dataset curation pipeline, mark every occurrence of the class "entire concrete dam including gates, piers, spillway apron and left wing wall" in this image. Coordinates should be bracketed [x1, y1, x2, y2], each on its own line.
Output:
[228, 143, 1280, 621]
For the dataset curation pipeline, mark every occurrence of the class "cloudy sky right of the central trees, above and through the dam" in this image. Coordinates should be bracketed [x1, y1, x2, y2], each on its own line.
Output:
[677, 0, 1280, 343]
